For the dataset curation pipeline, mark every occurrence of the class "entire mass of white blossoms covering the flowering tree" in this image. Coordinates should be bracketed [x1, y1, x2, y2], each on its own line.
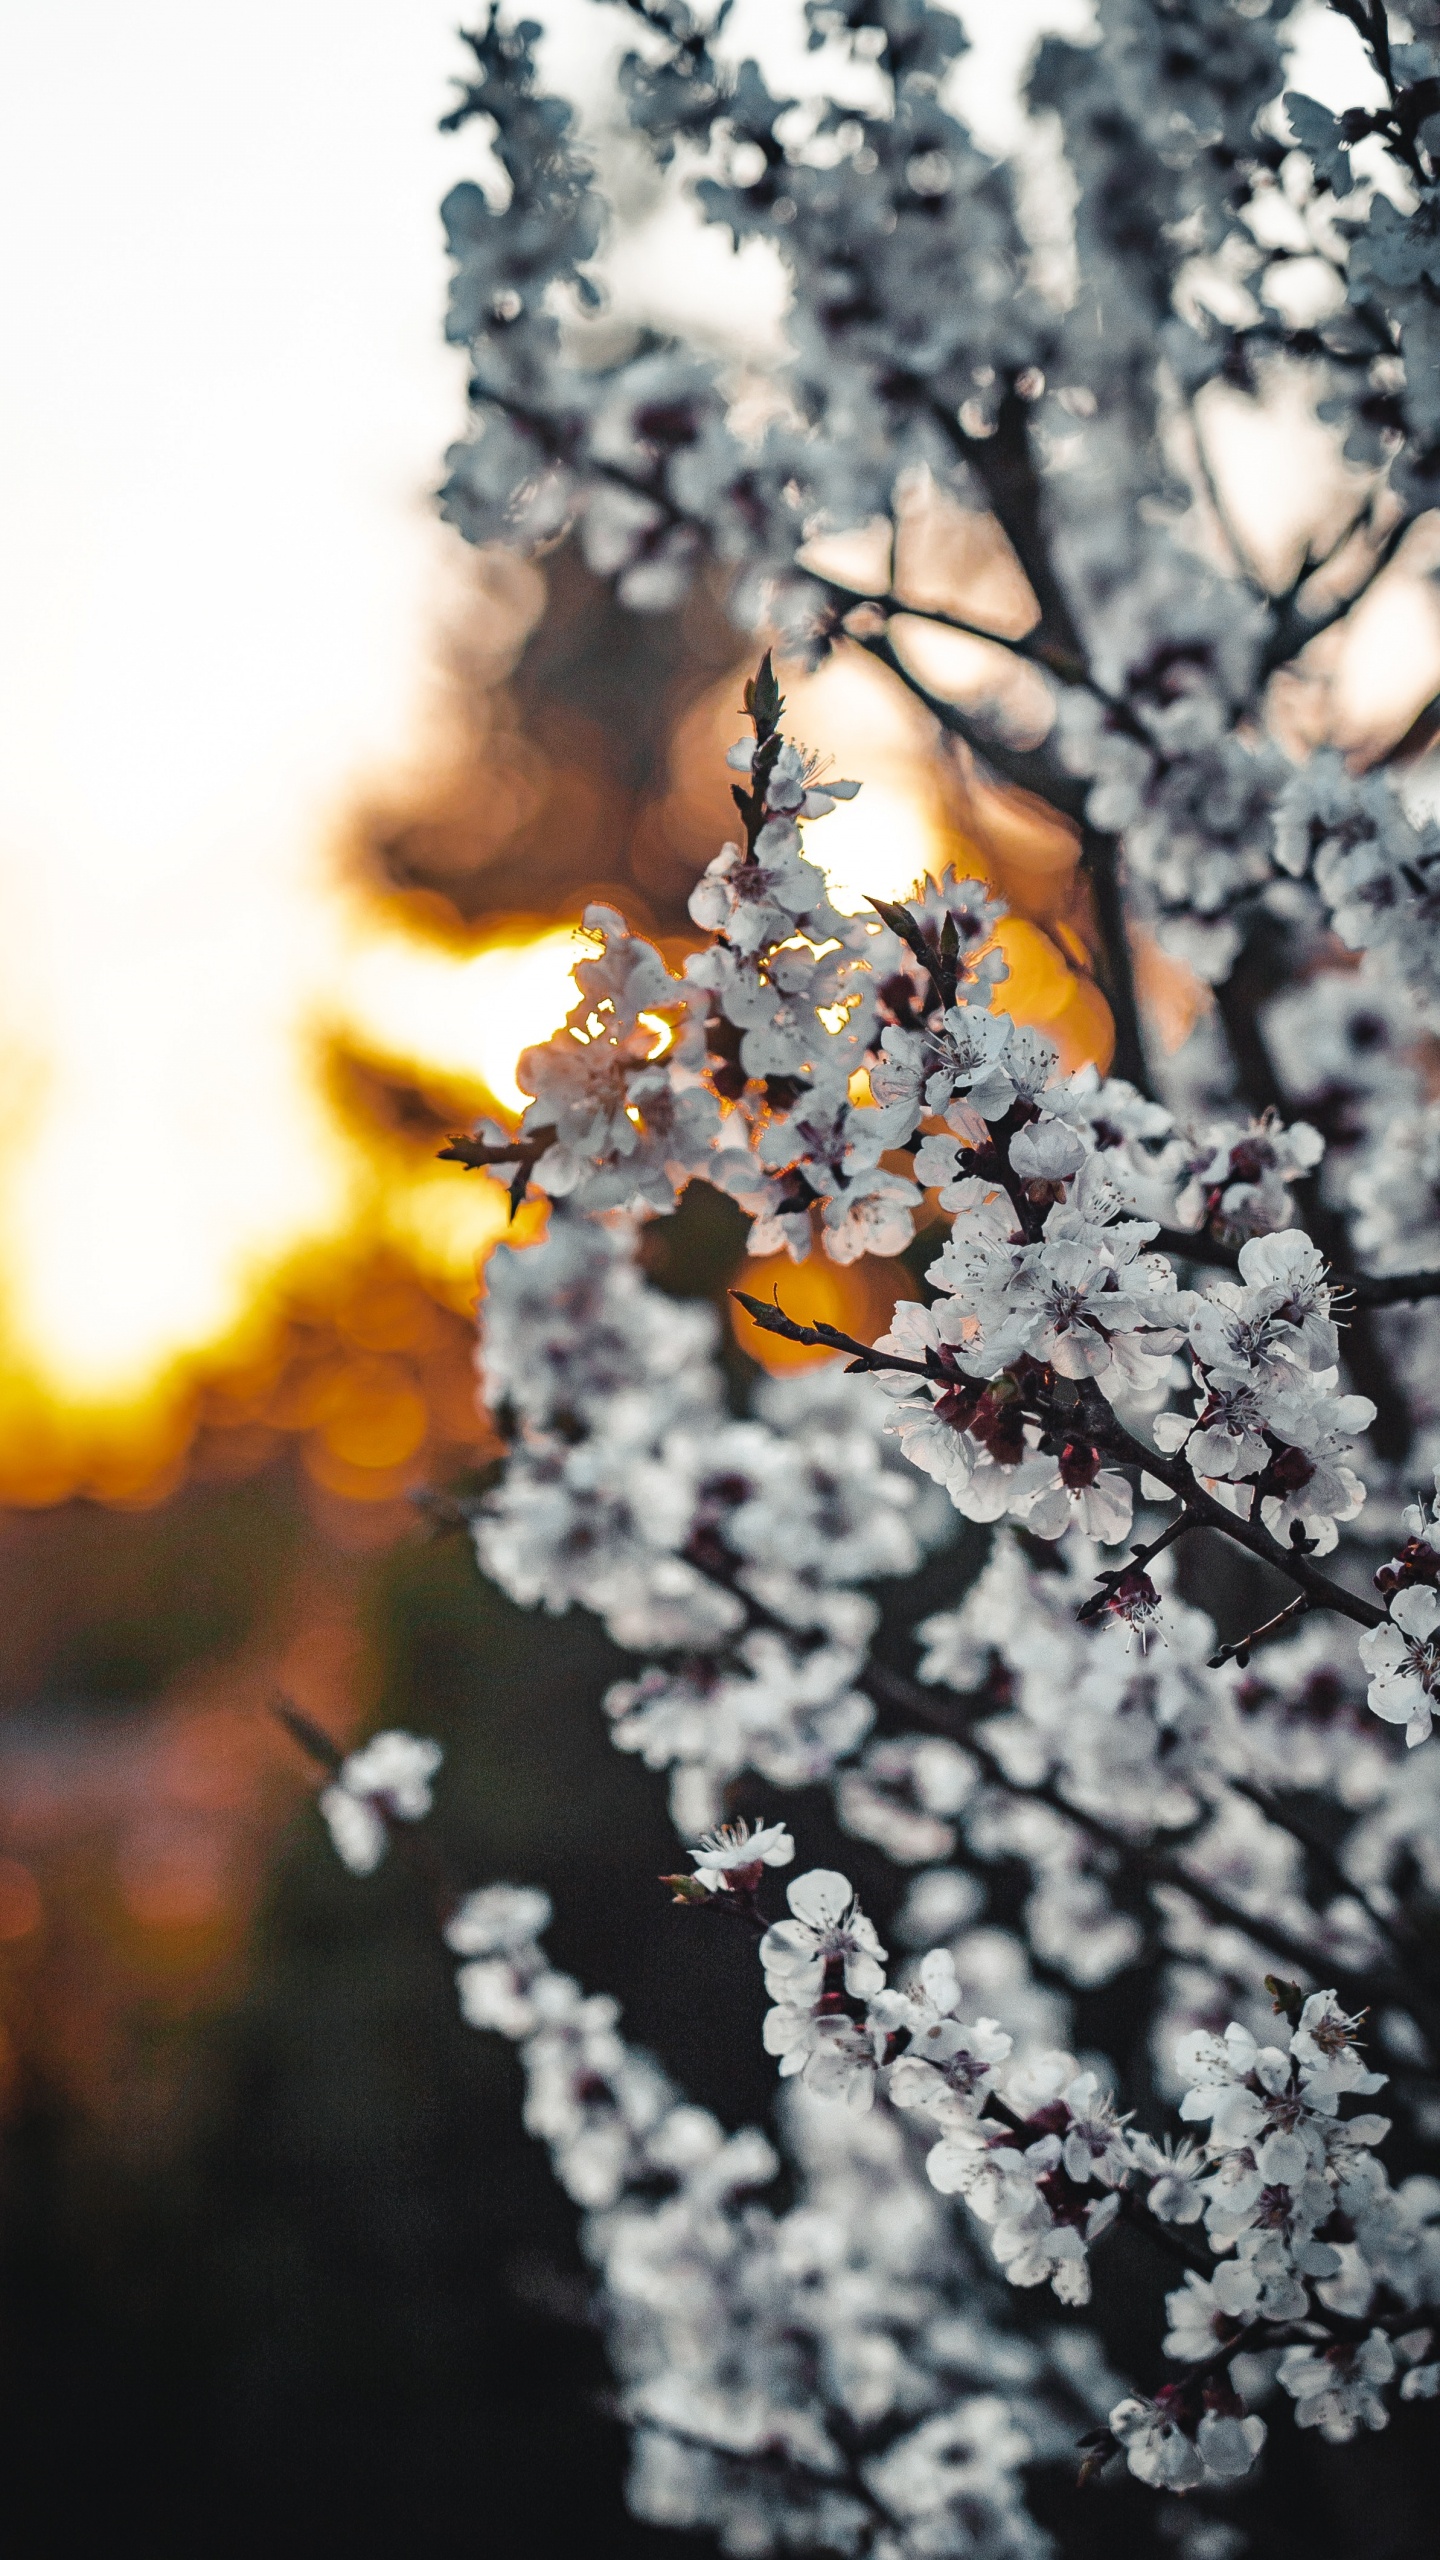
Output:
[297, 0, 1440, 2560]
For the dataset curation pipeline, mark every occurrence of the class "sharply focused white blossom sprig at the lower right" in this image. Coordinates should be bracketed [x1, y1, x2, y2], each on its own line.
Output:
[732, 1869, 1440, 2488]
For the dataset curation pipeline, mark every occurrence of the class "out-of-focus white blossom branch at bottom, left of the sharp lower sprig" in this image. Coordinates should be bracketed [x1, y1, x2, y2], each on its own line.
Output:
[425, 1836, 1096, 2560]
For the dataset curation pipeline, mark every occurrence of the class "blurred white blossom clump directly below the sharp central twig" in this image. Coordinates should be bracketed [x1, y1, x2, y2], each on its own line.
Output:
[471, 1206, 948, 1836]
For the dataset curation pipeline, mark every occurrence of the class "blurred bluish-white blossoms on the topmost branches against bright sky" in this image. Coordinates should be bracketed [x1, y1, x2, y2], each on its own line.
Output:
[443, 0, 1440, 998]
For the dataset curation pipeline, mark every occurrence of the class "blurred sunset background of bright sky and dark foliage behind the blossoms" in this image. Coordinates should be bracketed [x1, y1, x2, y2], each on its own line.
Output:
[0, 0, 1440, 2560]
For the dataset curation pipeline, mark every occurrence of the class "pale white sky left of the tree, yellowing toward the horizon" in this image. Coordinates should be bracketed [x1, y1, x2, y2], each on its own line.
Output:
[0, 0, 499, 1377]
